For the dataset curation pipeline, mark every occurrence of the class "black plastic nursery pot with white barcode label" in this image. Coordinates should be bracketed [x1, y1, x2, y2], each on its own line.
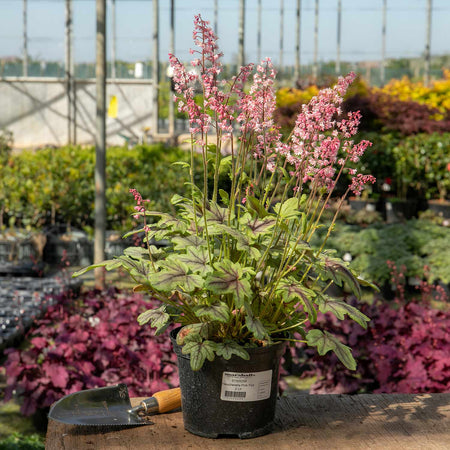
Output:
[170, 328, 285, 439]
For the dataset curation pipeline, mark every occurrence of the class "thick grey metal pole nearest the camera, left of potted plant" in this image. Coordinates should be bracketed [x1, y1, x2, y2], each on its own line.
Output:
[94, 0, 106, 289]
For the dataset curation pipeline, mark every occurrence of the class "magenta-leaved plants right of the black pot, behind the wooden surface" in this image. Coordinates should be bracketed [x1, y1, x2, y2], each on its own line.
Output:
[306, 262, 450, 394]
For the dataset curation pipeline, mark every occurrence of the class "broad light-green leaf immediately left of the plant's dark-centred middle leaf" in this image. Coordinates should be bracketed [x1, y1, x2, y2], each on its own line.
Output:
[150, 258, 203, 292]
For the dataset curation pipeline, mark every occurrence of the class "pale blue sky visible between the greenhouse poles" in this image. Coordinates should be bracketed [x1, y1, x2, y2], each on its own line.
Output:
[0, 0, 450, 64]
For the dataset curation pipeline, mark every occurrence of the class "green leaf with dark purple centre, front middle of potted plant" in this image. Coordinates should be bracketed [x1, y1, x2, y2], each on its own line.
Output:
[205, 259, 252, 308]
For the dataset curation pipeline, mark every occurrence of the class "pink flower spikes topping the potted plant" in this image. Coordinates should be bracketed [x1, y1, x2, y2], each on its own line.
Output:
[170, 15, 374, 197]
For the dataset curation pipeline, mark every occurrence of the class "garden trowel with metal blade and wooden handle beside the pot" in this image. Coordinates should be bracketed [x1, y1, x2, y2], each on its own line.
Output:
[48, 383, 181, 425]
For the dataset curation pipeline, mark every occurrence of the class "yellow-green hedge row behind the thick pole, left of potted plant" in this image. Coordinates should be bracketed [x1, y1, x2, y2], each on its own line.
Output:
[0, 145, 200, 230]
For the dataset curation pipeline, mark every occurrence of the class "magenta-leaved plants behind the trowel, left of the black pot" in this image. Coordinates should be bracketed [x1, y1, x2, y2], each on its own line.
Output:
[5, 290, 178, 415]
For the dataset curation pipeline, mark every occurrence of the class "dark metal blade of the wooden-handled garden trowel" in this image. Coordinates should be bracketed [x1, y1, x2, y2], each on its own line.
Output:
[48, 383, 152, 426]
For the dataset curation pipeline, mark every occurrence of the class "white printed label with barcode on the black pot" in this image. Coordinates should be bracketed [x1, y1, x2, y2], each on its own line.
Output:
[220, 370, 272, 402]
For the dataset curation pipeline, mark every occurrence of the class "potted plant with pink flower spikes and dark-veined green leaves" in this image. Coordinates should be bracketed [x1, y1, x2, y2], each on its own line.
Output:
[76, 16, 375, 370]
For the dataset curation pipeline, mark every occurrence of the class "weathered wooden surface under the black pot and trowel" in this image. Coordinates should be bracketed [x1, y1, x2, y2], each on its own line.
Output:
[46, 393, 450, 450]
